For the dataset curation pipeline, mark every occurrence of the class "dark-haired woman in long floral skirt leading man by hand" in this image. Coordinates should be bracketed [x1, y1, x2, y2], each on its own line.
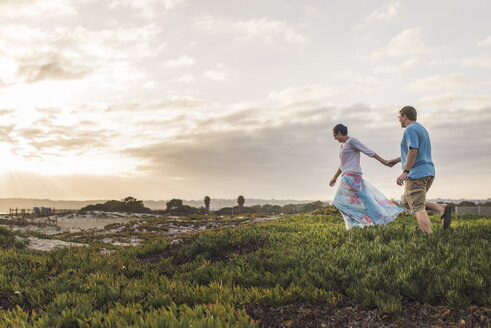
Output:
[329, 124, 402, 230]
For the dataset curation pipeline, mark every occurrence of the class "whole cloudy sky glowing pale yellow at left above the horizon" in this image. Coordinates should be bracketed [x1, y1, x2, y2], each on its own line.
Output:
[0, 0, 491, 200]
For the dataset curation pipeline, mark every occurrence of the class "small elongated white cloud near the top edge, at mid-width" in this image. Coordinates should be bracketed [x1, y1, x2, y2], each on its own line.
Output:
[195, 16, 305, 45]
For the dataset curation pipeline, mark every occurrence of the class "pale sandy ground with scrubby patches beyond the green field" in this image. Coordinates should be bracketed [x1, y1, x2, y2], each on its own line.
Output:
[3, 212, 277, 251]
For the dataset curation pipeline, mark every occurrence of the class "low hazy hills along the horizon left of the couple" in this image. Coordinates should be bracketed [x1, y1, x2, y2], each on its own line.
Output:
[0, 198, 322, 213]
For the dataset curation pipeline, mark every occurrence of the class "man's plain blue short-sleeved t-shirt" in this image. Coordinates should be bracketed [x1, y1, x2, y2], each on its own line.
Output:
[401, 122, 435, 179]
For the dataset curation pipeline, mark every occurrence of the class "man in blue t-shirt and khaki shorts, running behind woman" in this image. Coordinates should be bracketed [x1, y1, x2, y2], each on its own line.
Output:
[388, 106, 451, 235]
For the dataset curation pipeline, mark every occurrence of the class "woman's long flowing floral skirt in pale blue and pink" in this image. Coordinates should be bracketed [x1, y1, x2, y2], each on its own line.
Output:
[334, 174, 402, 230]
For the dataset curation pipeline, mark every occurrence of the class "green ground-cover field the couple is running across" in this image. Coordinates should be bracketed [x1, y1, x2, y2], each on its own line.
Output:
[0, 210, 491, 327]
